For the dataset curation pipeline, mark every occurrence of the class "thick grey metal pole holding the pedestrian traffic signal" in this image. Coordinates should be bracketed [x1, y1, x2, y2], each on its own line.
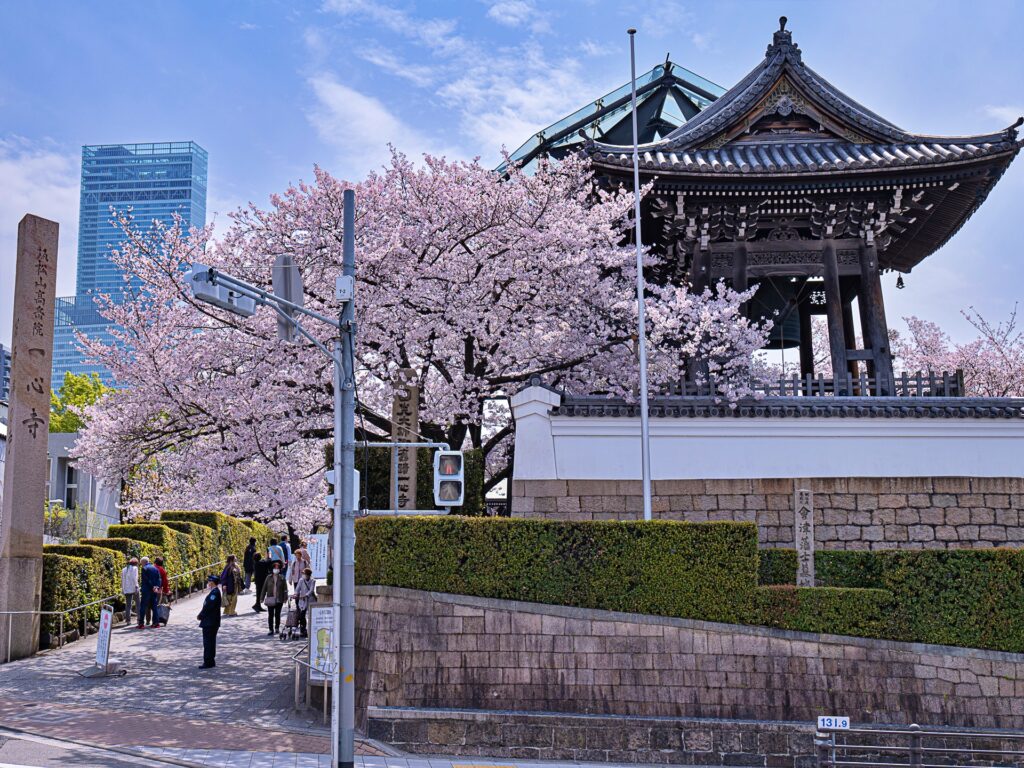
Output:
[334, 189, 355, 768]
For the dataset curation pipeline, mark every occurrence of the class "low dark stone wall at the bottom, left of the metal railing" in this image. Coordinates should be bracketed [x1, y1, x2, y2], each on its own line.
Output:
[368, 707, 817, 768]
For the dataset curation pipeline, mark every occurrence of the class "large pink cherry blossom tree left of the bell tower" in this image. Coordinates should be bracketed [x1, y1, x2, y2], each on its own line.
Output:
[77, 153, 766, 529]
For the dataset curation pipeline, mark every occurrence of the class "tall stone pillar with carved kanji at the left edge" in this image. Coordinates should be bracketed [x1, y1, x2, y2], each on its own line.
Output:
[0, 214, 57, 658]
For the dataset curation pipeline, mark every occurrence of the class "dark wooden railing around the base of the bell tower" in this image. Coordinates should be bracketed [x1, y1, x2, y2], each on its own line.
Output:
[666, 371, 966, 397]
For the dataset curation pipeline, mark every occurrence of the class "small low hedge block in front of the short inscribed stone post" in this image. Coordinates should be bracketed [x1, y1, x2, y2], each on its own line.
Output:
[756, 586, 893, 638]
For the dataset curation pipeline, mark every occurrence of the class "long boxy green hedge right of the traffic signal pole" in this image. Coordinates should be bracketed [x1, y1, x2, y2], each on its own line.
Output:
[356, 516, 758, 623]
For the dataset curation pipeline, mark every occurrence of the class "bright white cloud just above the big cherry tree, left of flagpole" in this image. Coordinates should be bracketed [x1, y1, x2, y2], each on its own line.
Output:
[308, 73, 454, 178]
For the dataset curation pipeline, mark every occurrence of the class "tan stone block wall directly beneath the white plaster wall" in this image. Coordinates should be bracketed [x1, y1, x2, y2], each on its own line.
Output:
[512, 477, 1024, 549]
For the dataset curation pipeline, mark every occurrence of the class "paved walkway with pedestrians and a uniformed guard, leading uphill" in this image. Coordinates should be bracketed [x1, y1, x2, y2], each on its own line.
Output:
[0, 593, 339, 753]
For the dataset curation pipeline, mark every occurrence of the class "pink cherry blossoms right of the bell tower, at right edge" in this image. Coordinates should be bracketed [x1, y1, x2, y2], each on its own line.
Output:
[891, 305, 1024, 397]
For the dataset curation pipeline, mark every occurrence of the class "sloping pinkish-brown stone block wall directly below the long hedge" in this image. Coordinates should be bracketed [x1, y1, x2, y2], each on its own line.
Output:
[356, 587, 1024, 729]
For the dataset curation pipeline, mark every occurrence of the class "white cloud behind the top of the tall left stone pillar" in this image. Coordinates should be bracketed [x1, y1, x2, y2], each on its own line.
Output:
[0, 136, 81, 344]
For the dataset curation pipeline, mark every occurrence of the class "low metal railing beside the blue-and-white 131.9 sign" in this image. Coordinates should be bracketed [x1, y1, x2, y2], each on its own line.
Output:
[814, 725, 1024, 768]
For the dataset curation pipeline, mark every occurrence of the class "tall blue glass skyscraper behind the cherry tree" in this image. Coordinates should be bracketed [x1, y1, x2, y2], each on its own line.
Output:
[53, 141, 207, 388]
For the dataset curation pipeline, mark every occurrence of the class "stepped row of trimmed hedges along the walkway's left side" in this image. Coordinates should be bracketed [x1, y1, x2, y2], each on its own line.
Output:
[42, 511, 271, 633]
